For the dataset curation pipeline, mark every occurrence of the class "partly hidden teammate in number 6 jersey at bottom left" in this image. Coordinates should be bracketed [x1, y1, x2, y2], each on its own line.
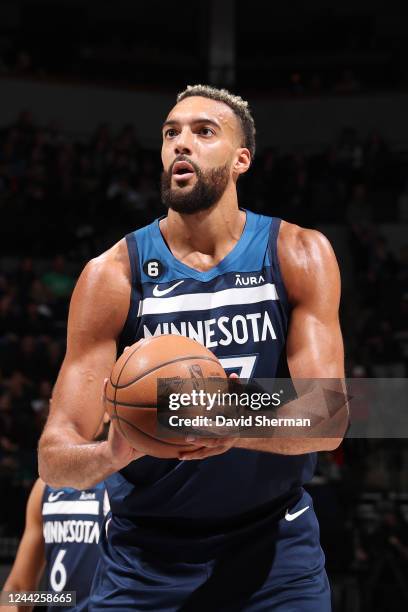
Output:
[2, 478, 109, 612]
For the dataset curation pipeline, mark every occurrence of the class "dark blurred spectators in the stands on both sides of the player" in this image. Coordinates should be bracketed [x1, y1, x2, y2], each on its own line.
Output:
[0, 111, 408, 612]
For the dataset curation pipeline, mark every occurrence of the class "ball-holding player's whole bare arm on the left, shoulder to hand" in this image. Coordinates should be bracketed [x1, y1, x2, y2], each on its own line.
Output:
[39, 241, 141, 489]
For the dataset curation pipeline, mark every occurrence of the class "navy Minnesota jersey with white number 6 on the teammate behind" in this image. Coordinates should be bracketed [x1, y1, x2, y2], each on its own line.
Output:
[42, 483, 109, 610]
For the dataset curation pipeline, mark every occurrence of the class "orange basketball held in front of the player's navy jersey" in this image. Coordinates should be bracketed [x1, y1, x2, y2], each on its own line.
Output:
[105, 335, 226, 458]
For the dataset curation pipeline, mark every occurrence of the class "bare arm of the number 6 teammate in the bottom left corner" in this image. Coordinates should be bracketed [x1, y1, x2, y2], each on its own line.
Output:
[2, 479, 45, 612]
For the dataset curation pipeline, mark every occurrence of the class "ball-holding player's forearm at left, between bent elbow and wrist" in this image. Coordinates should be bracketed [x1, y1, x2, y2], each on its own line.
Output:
[38, 431, 116, 489]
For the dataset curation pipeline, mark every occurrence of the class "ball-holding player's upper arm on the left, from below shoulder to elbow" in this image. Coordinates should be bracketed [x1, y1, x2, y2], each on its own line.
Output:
[46, 261, 130, 440]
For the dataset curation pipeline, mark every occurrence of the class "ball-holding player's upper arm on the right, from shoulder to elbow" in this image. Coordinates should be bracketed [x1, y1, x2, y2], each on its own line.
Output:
[287, 236, 348, 442]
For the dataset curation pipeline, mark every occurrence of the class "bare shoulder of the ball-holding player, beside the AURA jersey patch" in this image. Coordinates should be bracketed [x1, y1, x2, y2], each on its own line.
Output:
[278, 221, 340, 303]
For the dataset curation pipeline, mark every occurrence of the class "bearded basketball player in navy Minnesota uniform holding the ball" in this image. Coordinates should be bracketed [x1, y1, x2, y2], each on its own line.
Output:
[39, 85, 344, 612]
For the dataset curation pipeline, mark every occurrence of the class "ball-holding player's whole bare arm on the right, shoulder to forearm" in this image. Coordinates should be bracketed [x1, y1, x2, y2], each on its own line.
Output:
[236, 223, 348, 455]
